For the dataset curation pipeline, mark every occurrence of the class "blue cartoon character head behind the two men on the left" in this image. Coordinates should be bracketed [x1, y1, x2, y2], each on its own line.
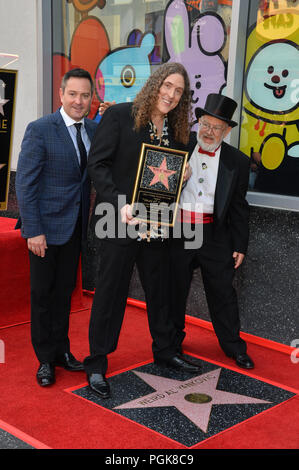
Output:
[96, 33, 155, 114]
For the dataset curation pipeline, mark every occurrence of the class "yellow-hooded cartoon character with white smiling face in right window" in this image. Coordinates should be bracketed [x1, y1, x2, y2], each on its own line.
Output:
[240, 9, 299, 196]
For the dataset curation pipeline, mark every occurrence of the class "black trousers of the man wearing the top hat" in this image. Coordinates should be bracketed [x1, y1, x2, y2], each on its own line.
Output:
[170, 224, 246, 356]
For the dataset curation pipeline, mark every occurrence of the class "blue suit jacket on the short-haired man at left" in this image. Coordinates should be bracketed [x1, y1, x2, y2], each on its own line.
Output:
[16, 110, 97, 245]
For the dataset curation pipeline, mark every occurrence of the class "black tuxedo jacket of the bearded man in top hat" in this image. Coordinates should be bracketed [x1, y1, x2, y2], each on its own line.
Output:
[189, 132, 249, 254]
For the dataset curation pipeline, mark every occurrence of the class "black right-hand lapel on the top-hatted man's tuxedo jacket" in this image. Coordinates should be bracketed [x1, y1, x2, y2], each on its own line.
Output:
[214, 142, 236, 223]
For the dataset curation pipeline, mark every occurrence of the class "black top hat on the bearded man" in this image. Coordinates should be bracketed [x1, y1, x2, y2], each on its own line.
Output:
[195, 93, 238, 127]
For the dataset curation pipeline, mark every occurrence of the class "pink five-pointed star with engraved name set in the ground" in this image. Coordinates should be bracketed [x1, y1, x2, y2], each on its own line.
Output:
[115, 368, 271, 433]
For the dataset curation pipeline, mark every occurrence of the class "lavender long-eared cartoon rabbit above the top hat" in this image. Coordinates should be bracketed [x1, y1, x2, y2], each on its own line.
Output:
[164, 0, 226, 130]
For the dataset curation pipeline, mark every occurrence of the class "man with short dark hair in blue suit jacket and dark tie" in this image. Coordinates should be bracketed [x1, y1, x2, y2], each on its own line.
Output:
[16, 69, 97, 386]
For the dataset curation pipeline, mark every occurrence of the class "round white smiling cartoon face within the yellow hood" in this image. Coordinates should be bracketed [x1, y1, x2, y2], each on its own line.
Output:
[246, 41, 299, 114]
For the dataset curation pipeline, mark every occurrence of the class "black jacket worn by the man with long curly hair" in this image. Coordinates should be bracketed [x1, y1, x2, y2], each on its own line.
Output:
[87, 103, 187, 244]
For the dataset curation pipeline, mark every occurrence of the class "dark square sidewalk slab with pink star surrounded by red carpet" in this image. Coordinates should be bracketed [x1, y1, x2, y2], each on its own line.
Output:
[71, 357, 295, 447]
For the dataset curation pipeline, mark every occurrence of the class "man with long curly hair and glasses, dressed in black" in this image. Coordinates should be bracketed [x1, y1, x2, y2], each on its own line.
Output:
[84, 63, 199, 398]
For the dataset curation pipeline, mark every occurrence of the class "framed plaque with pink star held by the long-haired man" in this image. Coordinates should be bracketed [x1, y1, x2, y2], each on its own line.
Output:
[132, 144, 188, 227]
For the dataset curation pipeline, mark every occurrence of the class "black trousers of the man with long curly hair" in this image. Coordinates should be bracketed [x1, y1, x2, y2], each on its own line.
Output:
[84, 241, 175, 374]
